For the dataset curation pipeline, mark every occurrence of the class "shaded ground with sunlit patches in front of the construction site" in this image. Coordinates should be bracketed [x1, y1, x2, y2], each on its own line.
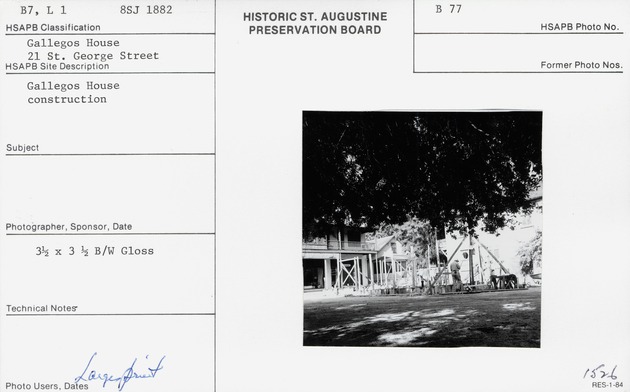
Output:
[304, 287, 541, 347]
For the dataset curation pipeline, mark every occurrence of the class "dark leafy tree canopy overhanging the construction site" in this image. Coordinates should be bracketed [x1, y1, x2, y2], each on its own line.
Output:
[303, 112, 542, 236]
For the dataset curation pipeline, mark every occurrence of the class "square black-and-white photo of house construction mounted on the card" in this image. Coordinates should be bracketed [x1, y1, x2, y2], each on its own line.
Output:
[302, 110, 543, 348]
